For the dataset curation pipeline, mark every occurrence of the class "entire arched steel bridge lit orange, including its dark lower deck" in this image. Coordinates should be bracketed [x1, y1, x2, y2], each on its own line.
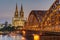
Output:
[14, 0, 60, 37]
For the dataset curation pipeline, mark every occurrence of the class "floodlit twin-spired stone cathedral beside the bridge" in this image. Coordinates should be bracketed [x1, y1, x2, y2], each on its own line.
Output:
[12, 4, 25, 27]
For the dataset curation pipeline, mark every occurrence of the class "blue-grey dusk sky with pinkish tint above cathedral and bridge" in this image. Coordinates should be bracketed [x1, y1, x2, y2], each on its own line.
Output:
[0, 0, 55, 23]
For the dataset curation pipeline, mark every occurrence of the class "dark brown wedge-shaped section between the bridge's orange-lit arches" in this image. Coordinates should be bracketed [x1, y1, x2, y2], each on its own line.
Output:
[29, 10, 47, 22]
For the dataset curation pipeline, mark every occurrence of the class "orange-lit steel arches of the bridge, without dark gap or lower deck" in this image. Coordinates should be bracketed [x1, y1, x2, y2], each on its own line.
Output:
[25, 0, 60, 32]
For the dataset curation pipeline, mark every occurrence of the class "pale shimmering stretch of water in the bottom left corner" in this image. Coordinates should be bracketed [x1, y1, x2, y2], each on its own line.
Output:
[0, 35, 25, 40]
